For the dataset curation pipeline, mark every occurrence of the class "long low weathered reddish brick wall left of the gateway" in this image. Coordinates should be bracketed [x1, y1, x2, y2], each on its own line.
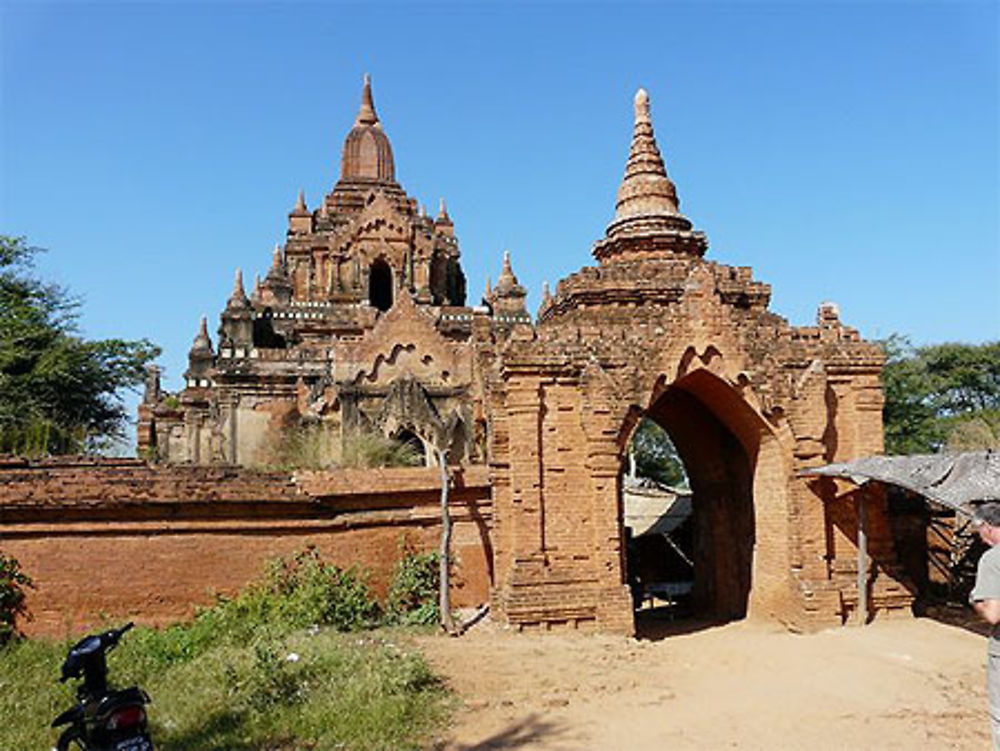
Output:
[0, 458, 492, 637]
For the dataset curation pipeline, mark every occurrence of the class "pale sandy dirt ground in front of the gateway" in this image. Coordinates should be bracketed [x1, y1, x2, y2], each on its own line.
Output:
[418, 618, 989, 751]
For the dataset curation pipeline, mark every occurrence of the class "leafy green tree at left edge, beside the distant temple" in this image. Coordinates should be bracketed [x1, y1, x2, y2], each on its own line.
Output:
[0, 235, 160, 455]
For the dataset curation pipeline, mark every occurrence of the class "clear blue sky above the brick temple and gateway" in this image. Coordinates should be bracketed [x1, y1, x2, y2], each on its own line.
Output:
[0, 0, 1000, 412]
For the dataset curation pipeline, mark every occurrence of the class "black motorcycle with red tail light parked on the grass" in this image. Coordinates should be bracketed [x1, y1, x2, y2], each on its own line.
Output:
[52, 623, 153, 751]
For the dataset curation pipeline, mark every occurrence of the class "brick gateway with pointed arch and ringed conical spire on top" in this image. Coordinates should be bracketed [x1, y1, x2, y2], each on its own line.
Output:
[488, 90, 910, 633]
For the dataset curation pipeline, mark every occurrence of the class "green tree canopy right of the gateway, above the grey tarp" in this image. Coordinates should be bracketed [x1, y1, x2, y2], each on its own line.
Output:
[882, 336, 1000, 454]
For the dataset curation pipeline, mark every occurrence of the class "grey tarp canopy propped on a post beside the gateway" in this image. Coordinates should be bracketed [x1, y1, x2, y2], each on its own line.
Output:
[802, 451, 1000, 515]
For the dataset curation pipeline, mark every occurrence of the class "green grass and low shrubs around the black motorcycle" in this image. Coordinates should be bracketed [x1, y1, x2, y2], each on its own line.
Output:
[0, 551, 451, 751]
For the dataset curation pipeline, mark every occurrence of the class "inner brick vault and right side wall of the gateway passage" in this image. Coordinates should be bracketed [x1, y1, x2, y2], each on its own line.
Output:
[645, 368, 791, 619]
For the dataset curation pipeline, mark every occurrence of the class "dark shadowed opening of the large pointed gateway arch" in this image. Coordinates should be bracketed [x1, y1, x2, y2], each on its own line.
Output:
[621, 371, 759, 637]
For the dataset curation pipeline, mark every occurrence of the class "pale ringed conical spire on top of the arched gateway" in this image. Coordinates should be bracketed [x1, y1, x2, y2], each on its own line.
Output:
[594, 89, 708, 261]
